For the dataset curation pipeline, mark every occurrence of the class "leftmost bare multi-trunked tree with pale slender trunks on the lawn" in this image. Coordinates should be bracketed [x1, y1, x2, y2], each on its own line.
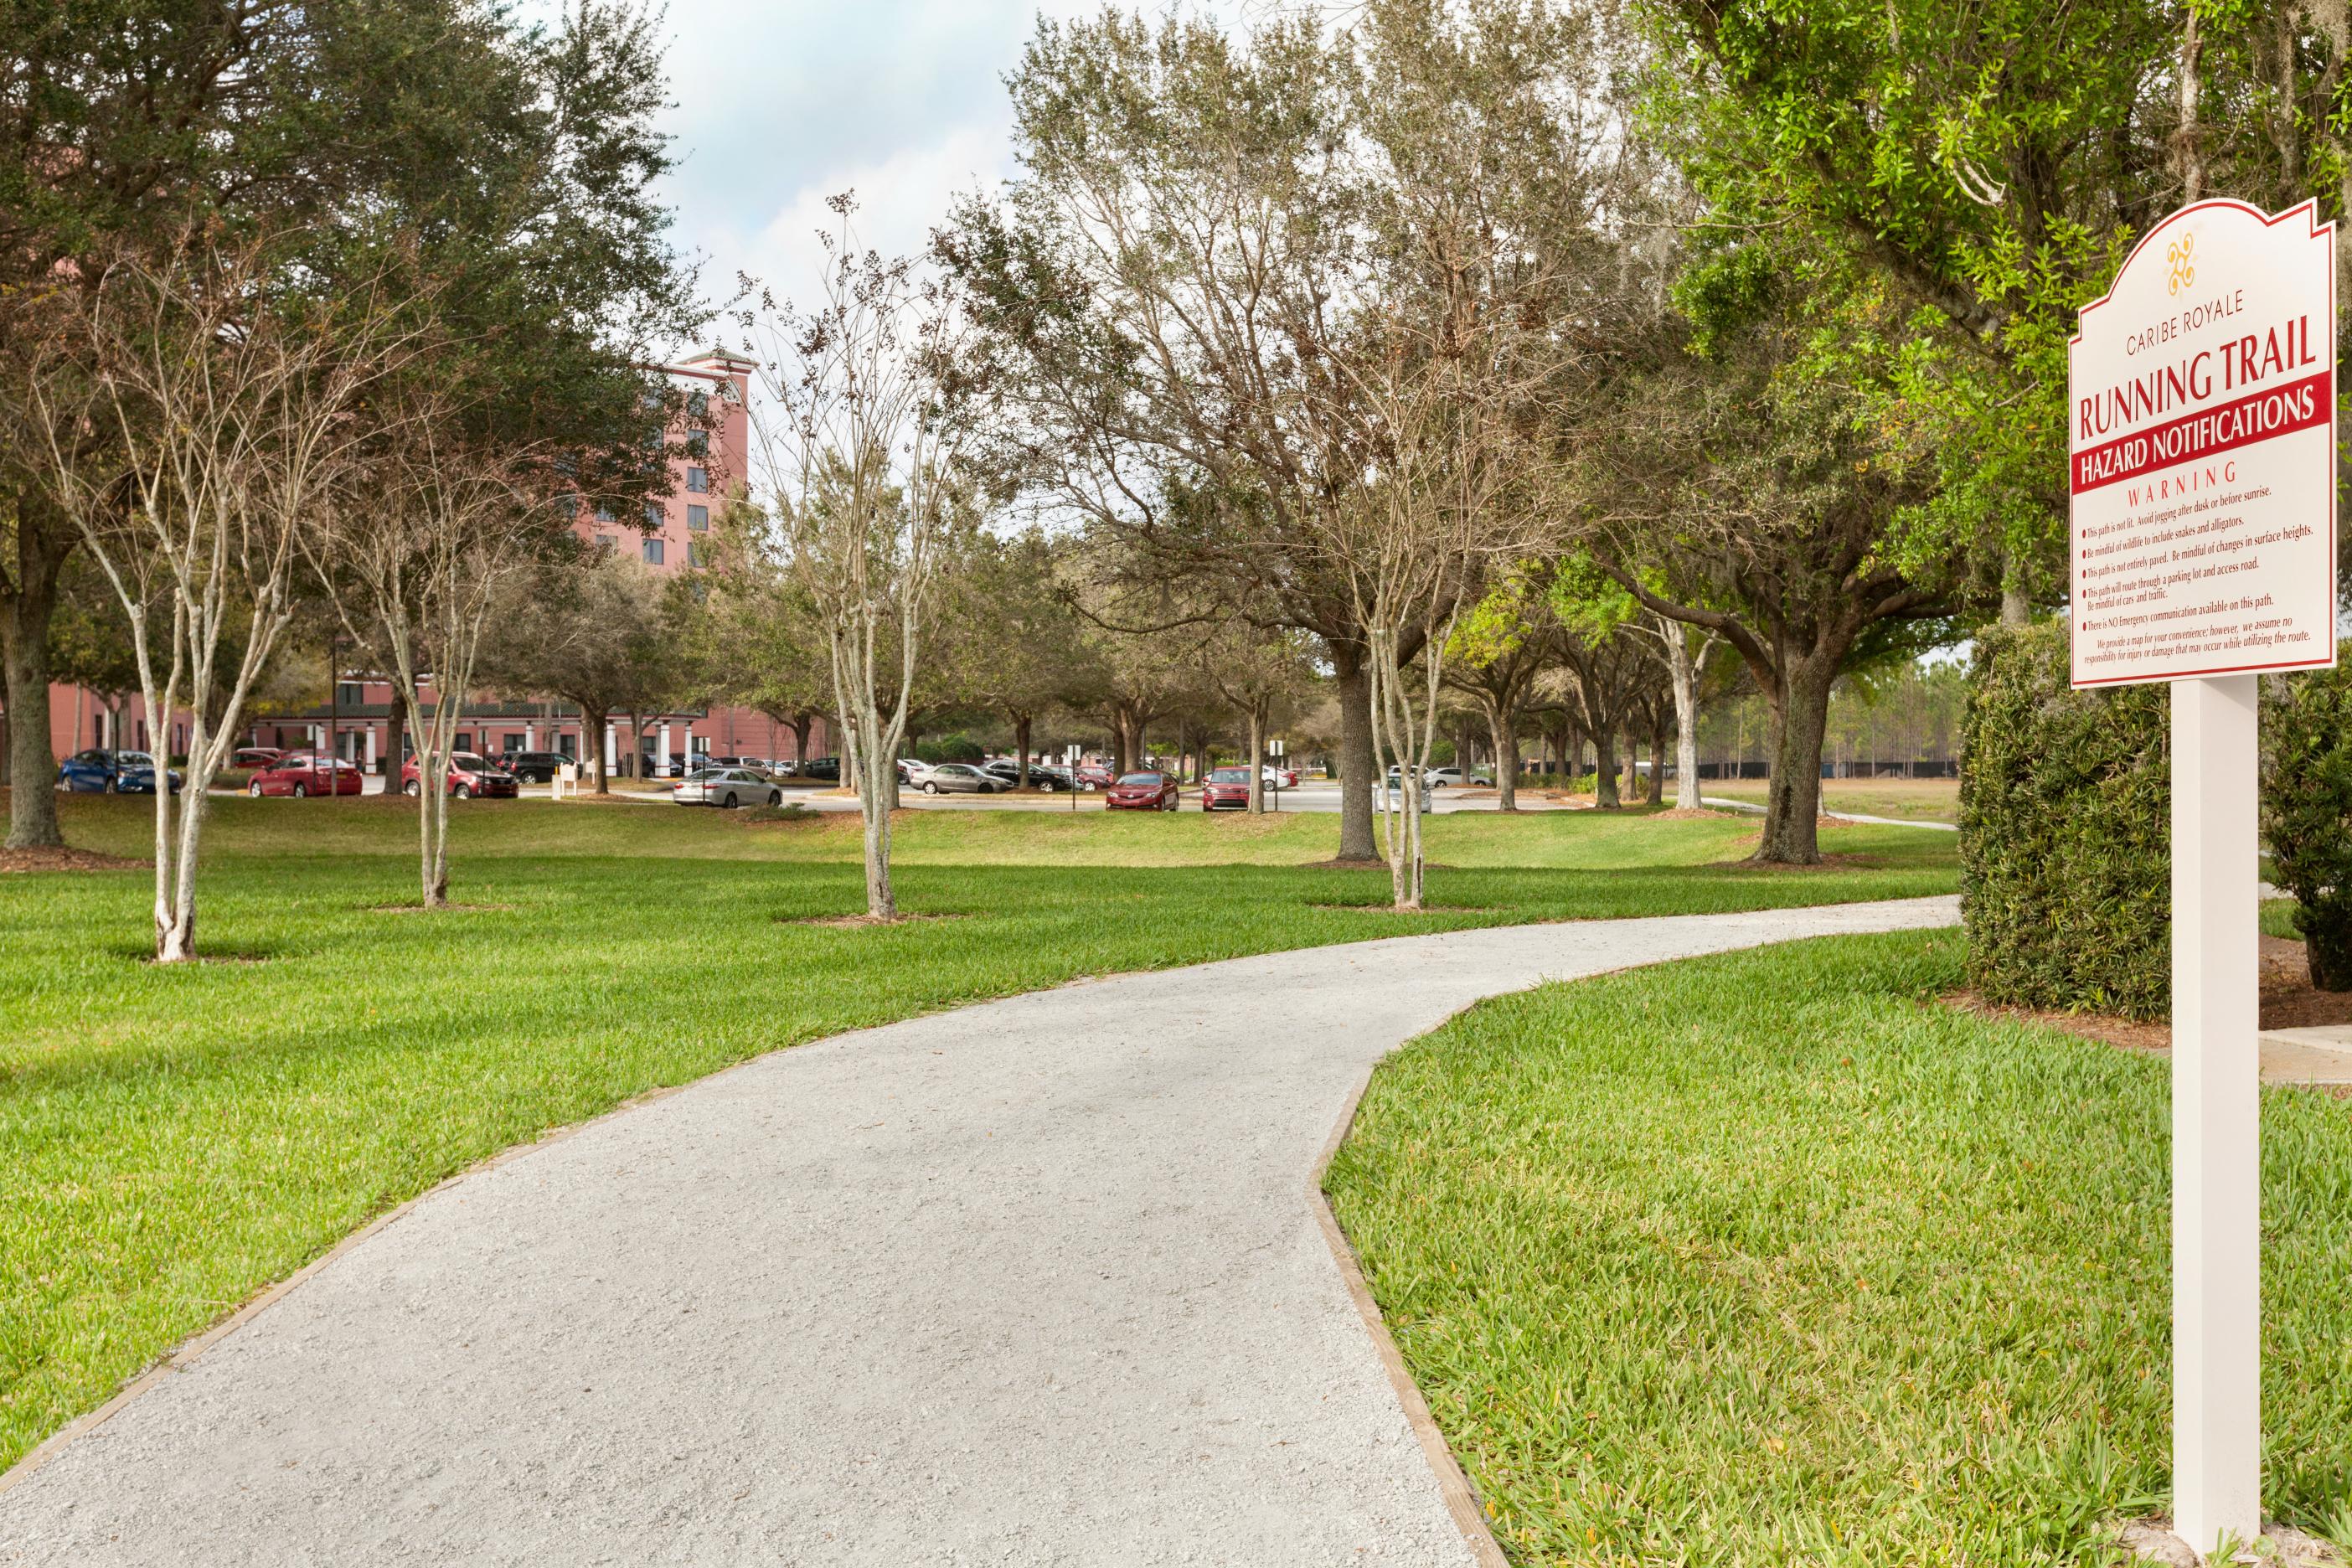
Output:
[31, 235, 411, 962]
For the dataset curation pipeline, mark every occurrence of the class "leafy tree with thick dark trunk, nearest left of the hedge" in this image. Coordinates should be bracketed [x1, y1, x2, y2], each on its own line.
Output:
[1578, 257, 1968, 865]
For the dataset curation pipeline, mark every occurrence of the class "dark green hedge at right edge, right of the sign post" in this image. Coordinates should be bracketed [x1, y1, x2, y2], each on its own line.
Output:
[2262, 642, 2352, 992]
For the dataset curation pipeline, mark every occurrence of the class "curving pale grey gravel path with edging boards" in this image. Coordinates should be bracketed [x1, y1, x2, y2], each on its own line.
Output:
[0, 898, 1957, 1568]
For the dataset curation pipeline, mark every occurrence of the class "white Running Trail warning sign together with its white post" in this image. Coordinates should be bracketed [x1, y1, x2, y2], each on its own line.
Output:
[2067, 200, 2335, 1551]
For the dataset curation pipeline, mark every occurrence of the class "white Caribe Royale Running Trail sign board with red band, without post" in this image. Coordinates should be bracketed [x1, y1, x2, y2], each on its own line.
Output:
[2067, 202, 2335, 687]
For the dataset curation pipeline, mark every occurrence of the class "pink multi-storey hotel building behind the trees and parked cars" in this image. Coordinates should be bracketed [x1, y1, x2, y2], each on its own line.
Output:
[49, 350, 830, 776]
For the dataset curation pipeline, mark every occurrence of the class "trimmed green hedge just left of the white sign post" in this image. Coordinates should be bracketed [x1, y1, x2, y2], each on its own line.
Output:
[1959, 626, 2171, 1018]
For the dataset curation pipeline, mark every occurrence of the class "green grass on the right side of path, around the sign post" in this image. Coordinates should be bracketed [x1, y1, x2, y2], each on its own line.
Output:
[1327, 926, 2352, 1565]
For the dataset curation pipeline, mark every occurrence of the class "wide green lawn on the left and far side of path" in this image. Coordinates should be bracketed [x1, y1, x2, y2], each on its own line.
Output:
[0, 797, 1957, 1465]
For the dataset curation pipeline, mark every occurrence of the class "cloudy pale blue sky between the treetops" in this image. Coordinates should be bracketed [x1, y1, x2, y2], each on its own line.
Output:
[588, 0, 1225, 345]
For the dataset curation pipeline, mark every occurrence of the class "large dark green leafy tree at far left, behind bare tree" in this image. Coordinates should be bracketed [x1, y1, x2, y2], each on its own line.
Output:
[0, 0, 692, 844]
